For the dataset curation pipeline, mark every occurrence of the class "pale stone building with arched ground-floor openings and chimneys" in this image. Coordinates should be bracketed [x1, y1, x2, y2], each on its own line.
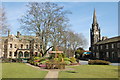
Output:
[1, 31, 41, 58]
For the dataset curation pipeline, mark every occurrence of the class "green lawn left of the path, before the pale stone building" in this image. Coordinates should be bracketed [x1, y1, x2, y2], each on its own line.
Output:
[2, 63, 47, 78]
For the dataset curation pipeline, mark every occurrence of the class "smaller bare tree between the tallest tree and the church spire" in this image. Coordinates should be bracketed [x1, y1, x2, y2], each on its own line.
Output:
[63, 30, 87, 56]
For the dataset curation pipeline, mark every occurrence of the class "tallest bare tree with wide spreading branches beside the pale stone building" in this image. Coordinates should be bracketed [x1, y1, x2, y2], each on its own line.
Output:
[20, 2, 69, 54]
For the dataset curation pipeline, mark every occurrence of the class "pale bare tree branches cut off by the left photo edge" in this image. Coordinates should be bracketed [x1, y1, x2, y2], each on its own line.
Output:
[0, 5, 9, 34]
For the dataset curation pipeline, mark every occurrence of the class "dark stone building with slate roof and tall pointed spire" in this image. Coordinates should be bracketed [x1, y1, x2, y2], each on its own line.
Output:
[90, 10, 120, 62]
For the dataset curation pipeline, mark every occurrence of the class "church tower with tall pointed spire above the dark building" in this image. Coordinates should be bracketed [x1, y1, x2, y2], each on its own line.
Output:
[90, 9, 101, 46]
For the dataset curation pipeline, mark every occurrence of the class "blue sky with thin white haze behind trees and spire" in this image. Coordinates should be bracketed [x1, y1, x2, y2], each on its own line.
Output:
[3, 2, 118, 49]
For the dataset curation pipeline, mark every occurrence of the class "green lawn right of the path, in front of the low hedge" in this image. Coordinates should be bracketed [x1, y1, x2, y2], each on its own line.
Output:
[59, 65, 118, 78]
